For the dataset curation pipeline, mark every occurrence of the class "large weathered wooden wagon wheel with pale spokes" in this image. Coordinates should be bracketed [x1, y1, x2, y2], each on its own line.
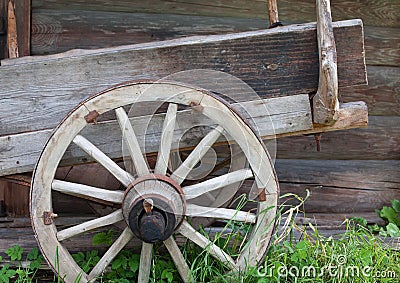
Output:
[30, 81, 278, 282]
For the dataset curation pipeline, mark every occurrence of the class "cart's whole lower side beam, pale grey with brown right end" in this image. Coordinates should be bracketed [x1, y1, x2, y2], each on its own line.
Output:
[0, 95, 368, 176]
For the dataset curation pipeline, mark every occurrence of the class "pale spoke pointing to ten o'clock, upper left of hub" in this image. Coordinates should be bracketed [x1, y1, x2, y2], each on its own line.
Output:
[73, 135, 134, 187]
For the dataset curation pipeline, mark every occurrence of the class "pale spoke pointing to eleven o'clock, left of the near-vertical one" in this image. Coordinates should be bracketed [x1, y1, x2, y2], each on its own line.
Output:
[115, 107, 149, 176]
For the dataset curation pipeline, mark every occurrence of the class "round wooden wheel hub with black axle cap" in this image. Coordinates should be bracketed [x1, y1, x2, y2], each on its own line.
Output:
[122, 174, 186, 243]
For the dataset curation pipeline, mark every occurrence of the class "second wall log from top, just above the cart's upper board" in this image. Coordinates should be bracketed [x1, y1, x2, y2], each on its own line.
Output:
[28, 10, 400, 66]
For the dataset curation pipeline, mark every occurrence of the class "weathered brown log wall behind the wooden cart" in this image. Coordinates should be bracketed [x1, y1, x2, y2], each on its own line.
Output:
[0, 0, 400, 217]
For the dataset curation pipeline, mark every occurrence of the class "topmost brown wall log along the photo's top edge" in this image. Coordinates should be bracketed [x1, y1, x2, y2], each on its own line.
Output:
[33, 0, 400, 27]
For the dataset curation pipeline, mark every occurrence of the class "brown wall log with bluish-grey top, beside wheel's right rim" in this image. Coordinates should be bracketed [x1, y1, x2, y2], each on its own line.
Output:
[275, 159, 400, 193]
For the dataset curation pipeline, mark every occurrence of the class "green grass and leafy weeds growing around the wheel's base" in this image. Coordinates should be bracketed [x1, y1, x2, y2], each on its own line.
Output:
[0, 199, 400, 283]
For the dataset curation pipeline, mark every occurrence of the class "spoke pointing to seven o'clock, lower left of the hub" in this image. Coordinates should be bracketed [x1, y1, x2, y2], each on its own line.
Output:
[88, 227, 133, 281]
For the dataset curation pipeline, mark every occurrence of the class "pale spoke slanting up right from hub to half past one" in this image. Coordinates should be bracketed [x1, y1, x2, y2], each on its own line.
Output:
[171, 126, 224, 184]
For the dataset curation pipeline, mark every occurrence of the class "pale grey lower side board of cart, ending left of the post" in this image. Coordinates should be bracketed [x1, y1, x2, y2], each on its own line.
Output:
[0, 95, 312, 175]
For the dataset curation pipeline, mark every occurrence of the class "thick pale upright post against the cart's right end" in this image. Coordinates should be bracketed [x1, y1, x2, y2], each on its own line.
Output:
[313, 0, 339, 125]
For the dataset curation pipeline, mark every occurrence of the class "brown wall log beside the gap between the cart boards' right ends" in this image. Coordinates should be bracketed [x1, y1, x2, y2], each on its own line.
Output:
[339, 66, 400, 116]
